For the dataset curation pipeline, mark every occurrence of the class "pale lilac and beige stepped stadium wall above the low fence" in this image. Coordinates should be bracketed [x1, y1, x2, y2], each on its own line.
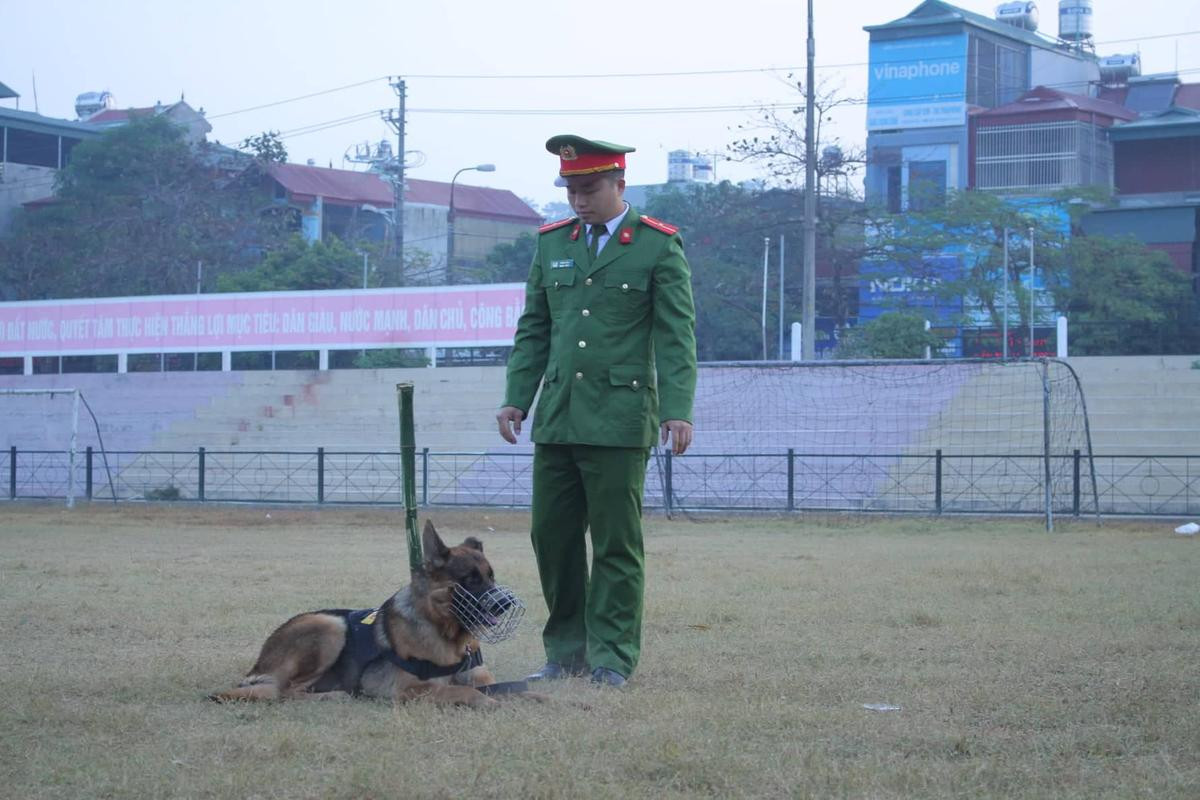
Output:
[0, 356, 1200, 456]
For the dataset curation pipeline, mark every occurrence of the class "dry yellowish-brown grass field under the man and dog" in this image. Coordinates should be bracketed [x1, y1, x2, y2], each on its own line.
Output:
[0, 504, 1200, 800]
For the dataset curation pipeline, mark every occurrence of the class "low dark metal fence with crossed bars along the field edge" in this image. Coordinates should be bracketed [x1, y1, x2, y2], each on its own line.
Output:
[0, 447, 1200, 517]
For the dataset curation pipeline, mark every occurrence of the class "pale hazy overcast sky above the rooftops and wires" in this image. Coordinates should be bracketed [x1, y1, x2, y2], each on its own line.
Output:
[0, 0, 1200, 209]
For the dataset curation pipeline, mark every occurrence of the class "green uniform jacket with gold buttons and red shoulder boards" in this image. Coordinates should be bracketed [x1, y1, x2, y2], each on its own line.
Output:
[504, 207, 696, 447]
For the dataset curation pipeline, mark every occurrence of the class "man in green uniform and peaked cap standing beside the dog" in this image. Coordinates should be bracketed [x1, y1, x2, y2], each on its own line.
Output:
[496, 136, 696, 686]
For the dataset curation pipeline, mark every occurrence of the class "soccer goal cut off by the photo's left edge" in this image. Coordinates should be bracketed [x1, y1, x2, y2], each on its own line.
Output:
[0, 389, 112, 509]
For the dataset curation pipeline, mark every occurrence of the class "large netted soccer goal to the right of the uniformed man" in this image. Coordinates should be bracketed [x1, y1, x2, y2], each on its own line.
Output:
[648, 359, 1097, 527]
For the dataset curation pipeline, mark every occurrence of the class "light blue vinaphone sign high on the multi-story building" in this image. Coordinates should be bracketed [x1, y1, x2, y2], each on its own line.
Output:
[866, 34, 967, 131]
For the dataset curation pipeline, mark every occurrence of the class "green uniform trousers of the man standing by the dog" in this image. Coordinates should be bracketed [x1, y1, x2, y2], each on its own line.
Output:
[532, 444, 649, 678]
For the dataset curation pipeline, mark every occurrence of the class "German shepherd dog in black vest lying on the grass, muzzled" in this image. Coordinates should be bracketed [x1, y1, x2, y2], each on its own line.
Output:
[210, 522, 525, 708]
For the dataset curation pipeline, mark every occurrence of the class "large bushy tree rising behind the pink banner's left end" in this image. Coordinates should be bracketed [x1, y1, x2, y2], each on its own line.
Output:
[0, 116, 283, 300]
